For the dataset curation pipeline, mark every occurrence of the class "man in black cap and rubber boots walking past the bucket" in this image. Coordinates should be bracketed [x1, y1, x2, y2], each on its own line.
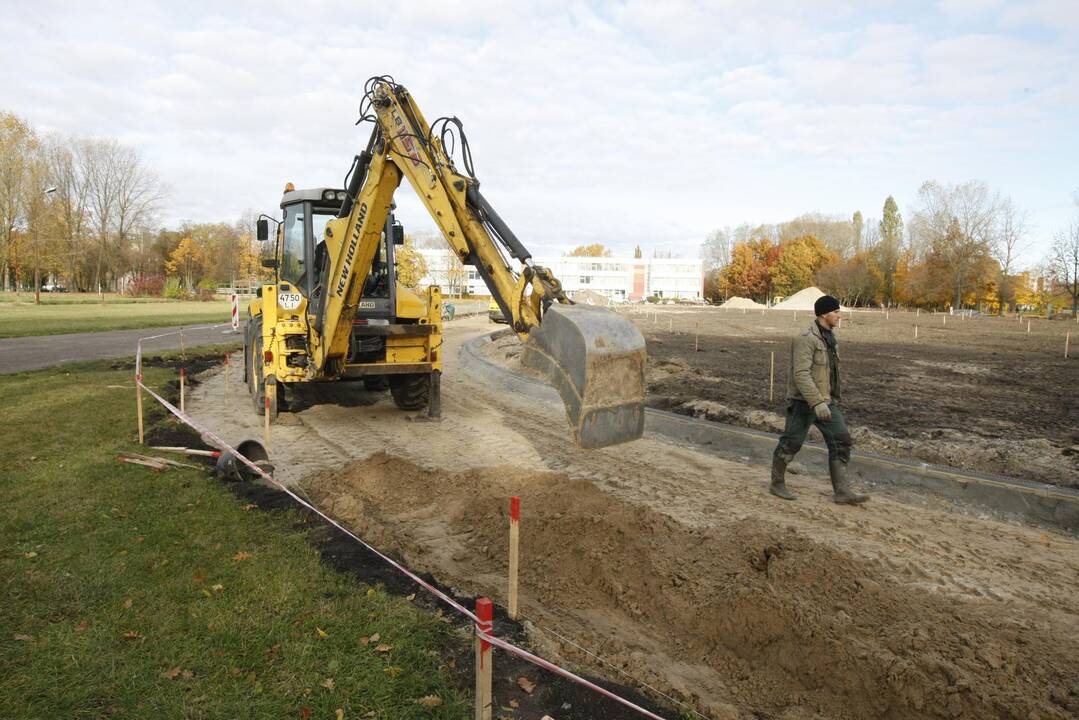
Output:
[768, 295, 870, 505]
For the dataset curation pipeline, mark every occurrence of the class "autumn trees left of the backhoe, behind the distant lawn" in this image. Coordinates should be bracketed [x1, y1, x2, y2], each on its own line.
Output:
[0, 112, 260, 297]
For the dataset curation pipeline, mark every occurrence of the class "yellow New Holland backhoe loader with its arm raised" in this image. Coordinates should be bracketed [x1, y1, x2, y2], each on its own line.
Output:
[244, 77, 645, 448]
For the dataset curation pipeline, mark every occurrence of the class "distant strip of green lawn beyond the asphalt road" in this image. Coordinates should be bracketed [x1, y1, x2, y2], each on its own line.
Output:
[0, 293, 238, 338]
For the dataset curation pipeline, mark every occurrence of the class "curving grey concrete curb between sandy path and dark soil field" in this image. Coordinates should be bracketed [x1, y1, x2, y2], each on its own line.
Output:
[460, 330, 1079, 534]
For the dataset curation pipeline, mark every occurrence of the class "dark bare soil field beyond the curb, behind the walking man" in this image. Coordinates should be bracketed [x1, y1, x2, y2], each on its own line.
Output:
[625, 307, 1079, 487]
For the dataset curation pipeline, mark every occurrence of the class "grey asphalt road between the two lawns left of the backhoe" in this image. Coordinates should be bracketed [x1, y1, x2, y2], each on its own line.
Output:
[0, 325, 243, 373]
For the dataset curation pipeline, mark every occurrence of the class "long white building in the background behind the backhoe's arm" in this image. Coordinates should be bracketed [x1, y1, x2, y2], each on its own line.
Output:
[420, 248, 705, 302]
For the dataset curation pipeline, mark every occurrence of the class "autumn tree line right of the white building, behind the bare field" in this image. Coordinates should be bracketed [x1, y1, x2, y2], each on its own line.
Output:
[702, 180, 1079, 313]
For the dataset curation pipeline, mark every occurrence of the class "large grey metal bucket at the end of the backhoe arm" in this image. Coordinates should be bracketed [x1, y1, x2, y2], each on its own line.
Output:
[521, 304, 645, 448]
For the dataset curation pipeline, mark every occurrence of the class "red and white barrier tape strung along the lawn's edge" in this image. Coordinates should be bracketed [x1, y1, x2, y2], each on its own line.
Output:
[135, 343, 666, 720]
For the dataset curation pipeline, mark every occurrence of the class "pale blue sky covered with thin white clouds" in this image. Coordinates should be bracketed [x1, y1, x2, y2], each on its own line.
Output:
[0, 0, 1079, 263]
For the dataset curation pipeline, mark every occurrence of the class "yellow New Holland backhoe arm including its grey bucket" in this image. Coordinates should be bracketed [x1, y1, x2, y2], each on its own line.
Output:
[312, 78, 644, 447]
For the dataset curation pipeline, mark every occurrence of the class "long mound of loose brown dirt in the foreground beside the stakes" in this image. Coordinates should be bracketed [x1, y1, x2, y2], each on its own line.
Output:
[304, 452, 1079, 718]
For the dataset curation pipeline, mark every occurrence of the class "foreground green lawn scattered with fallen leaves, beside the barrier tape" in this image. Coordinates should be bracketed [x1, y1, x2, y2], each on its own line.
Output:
[0, 363, 470, 720]
